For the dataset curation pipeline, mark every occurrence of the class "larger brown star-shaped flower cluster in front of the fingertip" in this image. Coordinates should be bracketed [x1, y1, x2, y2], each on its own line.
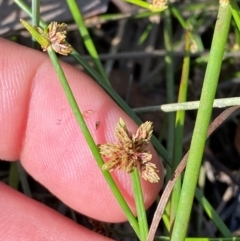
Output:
[99, 118, 160, 183]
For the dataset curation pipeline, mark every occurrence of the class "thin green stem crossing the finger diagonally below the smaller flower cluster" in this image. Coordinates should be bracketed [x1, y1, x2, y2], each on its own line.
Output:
[48, 47, 140, 237]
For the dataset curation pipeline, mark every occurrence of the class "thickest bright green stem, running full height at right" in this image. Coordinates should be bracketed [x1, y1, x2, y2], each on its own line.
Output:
[171, 4, 231, 241]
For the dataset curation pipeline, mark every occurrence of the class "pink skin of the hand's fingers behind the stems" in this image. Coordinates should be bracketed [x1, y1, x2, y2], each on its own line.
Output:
[0, 38, 163, 241]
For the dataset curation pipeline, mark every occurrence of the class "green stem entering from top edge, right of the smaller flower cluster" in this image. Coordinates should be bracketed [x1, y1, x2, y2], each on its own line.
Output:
[66, 0, 110, 85]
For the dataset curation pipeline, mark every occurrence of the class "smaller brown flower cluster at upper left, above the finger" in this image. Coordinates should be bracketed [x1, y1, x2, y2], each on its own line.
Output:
[37, 22, 73, 55]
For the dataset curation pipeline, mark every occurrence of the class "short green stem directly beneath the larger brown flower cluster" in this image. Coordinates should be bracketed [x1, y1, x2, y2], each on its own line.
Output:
[131, 168, 148, 241]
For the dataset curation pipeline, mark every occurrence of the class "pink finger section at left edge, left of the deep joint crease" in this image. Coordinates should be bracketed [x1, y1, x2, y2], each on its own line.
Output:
[0, 38, 46, 160]
